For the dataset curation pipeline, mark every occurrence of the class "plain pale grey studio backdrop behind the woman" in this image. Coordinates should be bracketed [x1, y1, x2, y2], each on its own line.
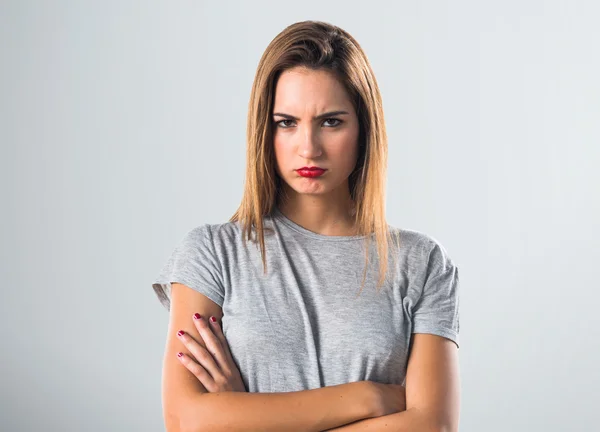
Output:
[0, 0, 600, 432]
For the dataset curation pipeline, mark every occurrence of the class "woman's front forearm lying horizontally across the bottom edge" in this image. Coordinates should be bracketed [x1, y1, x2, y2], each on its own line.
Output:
[169, 381, 377, 432]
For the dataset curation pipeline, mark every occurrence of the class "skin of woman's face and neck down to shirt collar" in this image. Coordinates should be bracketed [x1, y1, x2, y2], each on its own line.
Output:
[272, 67, 359, 236]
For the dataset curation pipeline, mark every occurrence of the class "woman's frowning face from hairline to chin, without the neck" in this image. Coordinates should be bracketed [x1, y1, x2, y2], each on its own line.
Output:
[272, 68, 359, 198]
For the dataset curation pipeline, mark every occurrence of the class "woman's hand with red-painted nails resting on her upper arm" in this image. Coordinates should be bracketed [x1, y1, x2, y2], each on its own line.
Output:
[177, 313, 246, 393]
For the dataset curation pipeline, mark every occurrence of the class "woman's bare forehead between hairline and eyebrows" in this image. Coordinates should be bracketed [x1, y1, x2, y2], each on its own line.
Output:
[275, 68, 351, 110]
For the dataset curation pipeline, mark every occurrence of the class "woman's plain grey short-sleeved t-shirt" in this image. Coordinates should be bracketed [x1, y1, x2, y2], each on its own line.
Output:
[152, 208, 459, 392]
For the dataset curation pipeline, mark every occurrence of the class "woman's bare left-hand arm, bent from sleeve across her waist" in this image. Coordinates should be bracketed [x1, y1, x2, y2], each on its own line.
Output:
[162, 283, 382, 432]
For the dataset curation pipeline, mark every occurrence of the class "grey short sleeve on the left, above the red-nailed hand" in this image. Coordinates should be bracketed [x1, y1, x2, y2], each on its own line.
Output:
[152, 224, 224, 310]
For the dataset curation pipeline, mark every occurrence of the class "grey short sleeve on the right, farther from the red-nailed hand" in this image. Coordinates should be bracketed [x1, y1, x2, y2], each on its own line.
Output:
[412, 240, 460, 347]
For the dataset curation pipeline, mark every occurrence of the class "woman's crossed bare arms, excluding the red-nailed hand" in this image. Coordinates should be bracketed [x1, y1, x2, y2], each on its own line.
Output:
[162, 283, 460, 432]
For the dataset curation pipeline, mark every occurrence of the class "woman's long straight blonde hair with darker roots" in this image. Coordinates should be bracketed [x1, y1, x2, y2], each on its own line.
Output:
[229, 20, 399, 291]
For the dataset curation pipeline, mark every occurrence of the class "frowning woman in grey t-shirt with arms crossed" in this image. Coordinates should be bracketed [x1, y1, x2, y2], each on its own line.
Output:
[153, 21, 459, 431]
